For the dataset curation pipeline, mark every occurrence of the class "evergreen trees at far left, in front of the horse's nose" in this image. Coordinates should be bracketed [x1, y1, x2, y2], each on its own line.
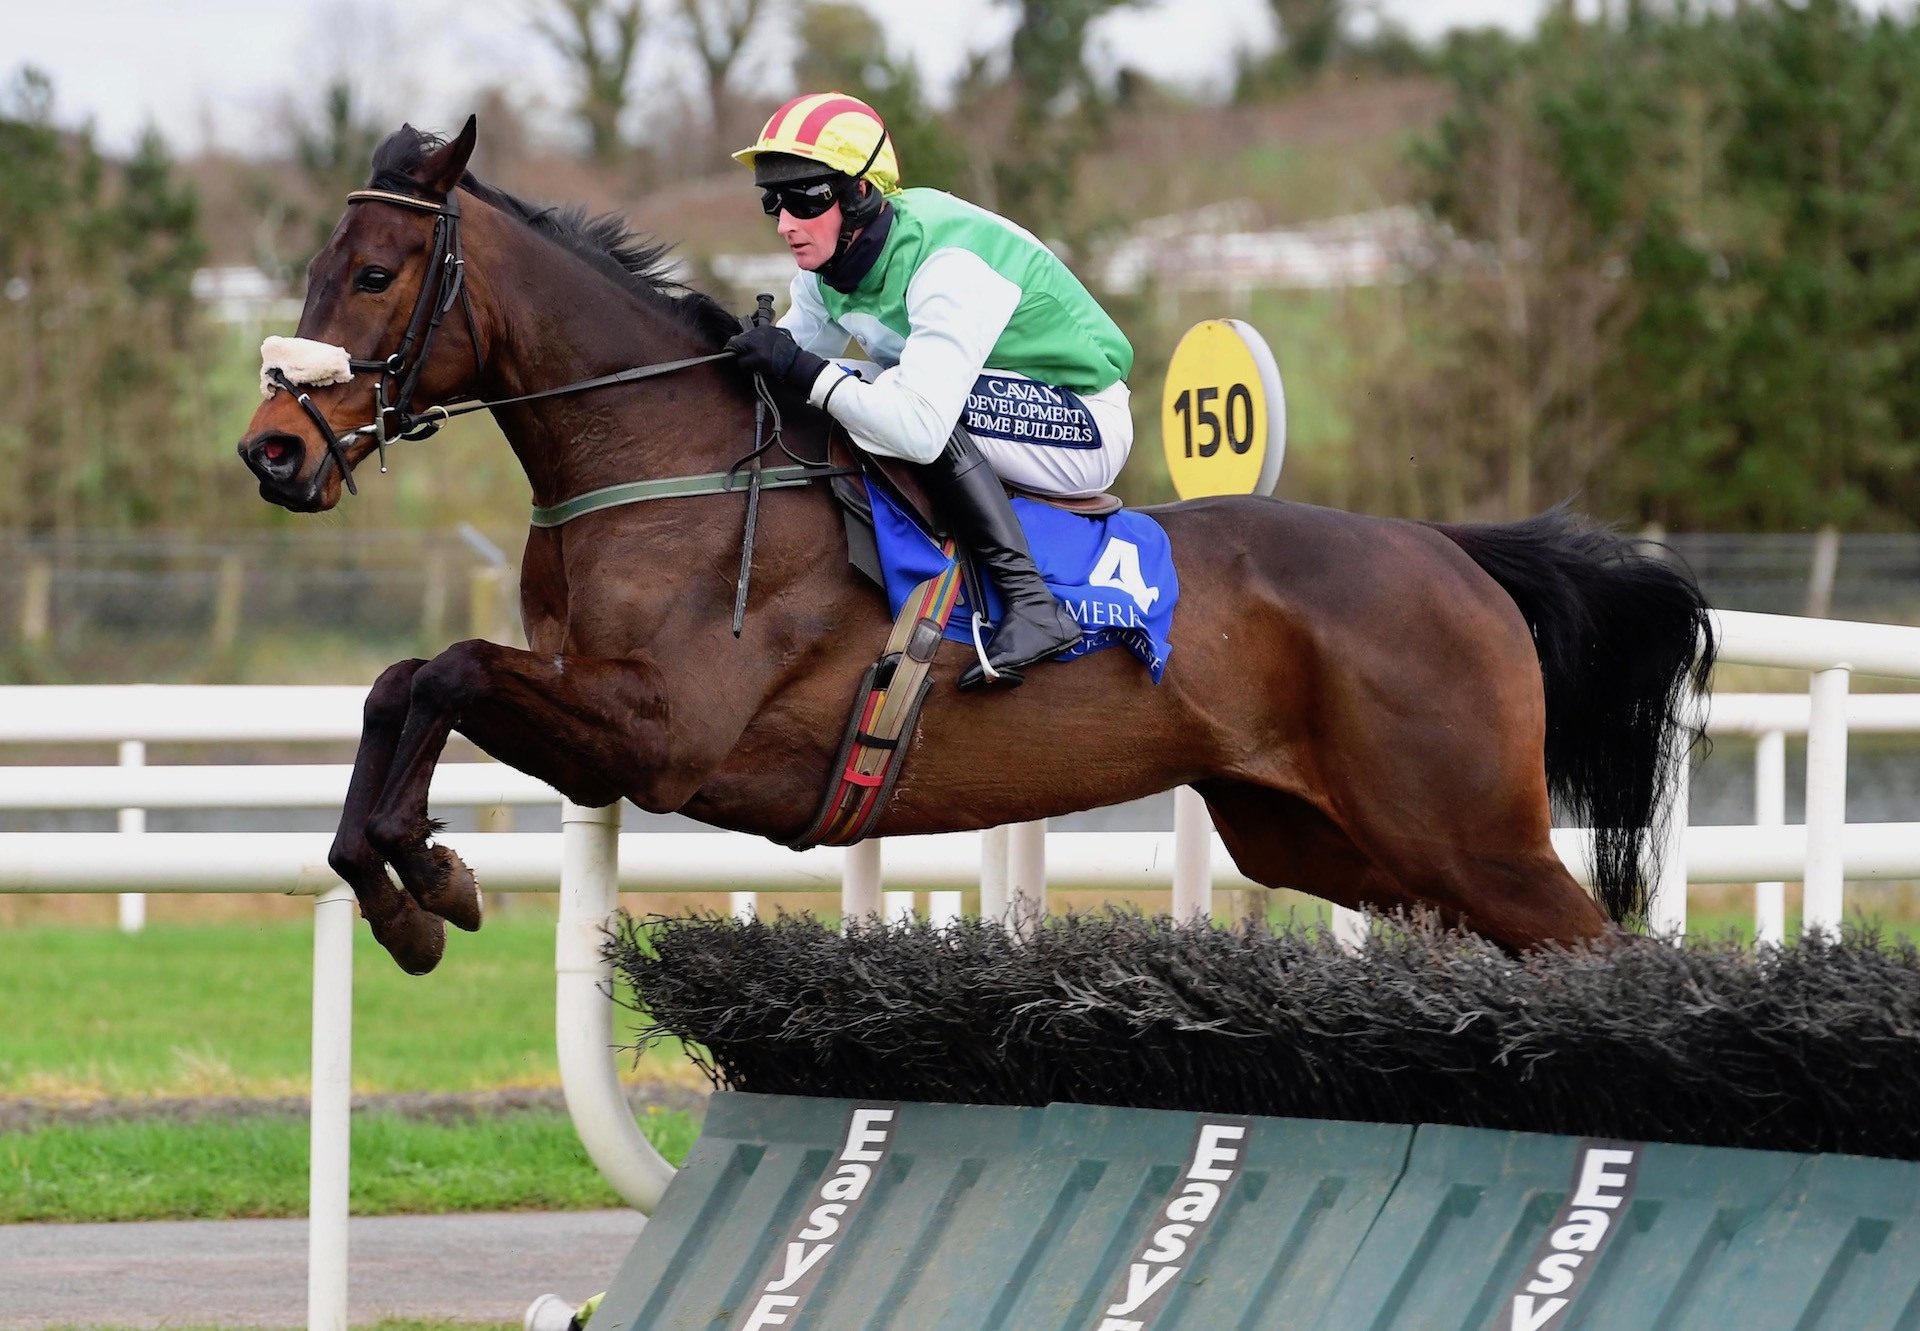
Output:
[0, 69, 227, 534]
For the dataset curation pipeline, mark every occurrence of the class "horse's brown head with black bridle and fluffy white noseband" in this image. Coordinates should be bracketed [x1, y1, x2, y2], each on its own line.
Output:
[240, 117, 480, 513]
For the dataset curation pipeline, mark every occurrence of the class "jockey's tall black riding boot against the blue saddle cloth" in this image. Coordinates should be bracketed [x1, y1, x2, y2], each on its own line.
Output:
[920, 426, 1081, 690]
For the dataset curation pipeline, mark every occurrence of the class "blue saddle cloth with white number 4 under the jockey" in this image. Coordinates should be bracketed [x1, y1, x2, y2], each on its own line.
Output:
[866, 480, 1181, 684]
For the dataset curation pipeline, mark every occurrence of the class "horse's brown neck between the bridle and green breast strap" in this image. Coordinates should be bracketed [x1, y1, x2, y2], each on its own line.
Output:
[476, 238, 753, 505]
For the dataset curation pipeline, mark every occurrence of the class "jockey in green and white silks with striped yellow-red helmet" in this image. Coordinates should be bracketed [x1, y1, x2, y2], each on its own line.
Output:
[728, 92, 1133, 688]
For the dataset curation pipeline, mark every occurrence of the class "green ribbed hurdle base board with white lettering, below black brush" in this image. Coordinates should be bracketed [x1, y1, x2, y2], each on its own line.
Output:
[588, 1093, 1920, 1331]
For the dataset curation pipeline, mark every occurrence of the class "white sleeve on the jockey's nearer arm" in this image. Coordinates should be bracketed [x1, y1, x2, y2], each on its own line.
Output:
[808, 250, 1021, 463]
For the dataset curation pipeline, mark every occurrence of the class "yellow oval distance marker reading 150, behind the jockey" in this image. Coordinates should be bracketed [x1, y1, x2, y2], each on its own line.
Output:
[1160, 319, 1286, 499]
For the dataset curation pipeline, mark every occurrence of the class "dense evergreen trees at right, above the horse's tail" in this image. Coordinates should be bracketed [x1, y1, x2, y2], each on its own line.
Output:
[1359, 0, 1920, 530]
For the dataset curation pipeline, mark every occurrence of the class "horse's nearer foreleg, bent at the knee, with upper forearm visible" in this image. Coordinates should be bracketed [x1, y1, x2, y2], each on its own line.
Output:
[367, 640, 666, 960]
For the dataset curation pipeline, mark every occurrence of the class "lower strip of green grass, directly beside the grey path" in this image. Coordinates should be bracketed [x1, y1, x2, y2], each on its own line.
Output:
[0, 1110, 697, 1223]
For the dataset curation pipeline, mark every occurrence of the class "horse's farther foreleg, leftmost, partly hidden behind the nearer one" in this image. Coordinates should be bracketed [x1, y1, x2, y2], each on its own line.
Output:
[326, 661, 447, 976]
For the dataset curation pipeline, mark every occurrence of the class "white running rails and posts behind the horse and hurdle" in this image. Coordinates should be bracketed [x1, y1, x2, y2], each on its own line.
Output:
[11, 613, 1920, 1331]
